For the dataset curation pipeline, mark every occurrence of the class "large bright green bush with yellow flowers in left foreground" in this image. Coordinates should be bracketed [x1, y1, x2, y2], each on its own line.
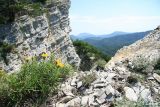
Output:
[0, 60, 72, 107]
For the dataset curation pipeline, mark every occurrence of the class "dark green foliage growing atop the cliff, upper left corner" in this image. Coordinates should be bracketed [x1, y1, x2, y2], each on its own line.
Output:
[0, 0, 47, 24]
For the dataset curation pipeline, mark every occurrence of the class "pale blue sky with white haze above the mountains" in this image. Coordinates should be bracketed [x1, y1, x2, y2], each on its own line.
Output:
[70, 0, 160, 35]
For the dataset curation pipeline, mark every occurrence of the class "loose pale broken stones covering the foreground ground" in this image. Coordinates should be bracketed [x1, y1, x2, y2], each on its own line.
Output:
[42, 70, 160, 107]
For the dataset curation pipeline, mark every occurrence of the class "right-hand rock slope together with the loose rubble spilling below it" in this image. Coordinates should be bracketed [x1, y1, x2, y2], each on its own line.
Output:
[43, 27, 160, 107]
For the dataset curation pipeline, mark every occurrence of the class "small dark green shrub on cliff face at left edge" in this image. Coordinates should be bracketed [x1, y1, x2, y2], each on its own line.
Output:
[0, 42, 14, 64]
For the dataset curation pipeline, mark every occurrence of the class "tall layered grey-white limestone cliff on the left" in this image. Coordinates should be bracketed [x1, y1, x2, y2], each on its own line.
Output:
[0, 0, 80, 72]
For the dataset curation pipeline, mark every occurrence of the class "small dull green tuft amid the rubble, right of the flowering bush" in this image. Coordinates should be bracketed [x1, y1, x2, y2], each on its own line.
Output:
[80, 73, 97, 88]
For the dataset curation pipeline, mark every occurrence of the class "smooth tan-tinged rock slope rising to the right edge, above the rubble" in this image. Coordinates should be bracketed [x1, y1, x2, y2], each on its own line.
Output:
[106, 27, 160, 73]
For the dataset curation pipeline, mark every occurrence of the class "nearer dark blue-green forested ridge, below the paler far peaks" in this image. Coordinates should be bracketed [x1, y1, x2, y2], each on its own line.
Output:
[83, 31, 150, 56]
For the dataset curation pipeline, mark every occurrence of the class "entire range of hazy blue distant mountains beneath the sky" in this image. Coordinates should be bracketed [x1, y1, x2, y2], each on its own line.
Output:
[71, 31, 150, 56]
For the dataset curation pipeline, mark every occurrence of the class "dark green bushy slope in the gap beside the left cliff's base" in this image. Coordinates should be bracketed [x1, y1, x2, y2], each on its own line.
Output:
[73, 40, 110, 70]
